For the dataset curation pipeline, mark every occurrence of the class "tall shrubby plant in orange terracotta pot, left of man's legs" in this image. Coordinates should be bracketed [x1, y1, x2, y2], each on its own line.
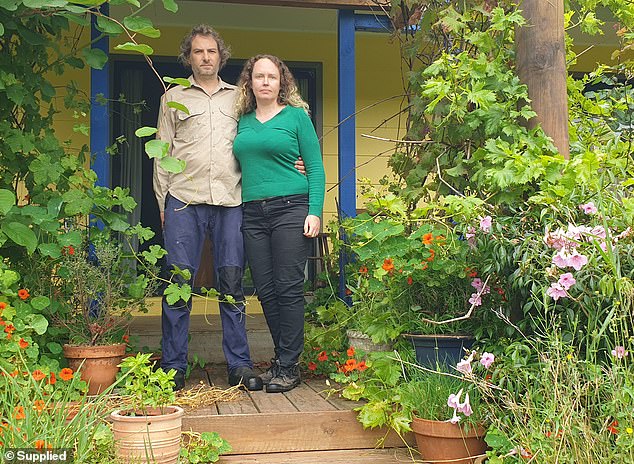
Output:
[53, 237, 157, 395]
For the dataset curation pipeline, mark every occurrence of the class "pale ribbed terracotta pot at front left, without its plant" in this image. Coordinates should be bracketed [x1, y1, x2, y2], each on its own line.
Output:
[110, 406, 184, 464]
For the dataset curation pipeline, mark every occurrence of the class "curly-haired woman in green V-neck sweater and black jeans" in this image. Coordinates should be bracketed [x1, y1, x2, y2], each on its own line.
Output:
[233, 55, 325, 393]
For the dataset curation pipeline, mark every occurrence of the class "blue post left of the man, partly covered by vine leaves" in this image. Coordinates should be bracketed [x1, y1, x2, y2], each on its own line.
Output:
[90, 3, 110, 187]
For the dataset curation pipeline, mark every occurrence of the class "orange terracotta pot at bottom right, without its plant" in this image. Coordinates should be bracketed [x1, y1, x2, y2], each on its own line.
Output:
[411, 417, 487, 464]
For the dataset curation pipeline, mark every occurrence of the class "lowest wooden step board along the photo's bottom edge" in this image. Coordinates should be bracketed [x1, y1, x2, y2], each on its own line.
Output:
[218, 448, 414, 464]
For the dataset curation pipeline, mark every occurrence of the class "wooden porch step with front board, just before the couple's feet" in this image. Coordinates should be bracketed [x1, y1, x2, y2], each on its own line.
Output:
[183, 365, 414, 454]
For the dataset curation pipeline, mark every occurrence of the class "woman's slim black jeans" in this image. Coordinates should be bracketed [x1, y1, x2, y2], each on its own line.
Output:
[242, 195, 310, 367]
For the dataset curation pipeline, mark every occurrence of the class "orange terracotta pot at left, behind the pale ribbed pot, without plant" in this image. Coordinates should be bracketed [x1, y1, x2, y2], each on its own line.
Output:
[64, 343, 126, 395]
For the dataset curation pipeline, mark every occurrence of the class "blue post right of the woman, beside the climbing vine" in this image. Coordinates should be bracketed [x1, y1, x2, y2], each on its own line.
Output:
[337, 10, 357, 298]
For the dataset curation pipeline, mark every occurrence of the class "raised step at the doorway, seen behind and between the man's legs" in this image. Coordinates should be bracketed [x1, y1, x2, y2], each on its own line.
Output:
[130, 313, 273, 363]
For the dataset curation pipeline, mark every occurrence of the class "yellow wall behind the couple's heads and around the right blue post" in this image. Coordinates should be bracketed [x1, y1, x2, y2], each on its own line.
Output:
[107, 26, 402, 221]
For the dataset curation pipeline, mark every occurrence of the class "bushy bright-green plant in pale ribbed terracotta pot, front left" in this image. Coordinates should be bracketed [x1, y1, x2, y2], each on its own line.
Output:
[110, 353, 184, 464]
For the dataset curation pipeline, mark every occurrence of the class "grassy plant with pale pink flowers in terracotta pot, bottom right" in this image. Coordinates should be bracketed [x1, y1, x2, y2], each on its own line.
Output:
[342, 350, 493, 464]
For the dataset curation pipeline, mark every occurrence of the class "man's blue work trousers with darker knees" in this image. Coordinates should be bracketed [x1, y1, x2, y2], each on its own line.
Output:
[161, 195, 253, 372]
